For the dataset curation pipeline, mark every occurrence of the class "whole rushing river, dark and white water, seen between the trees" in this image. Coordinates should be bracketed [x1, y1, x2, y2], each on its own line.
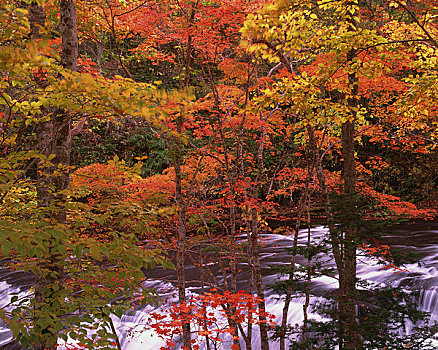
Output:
[0, 221, 438, 350]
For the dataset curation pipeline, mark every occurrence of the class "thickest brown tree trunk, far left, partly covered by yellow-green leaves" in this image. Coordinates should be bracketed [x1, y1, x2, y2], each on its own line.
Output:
[30, 0, 78, 350]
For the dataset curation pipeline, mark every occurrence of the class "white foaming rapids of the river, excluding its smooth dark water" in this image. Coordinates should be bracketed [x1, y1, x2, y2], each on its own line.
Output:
[0, 226, 438, 350]
